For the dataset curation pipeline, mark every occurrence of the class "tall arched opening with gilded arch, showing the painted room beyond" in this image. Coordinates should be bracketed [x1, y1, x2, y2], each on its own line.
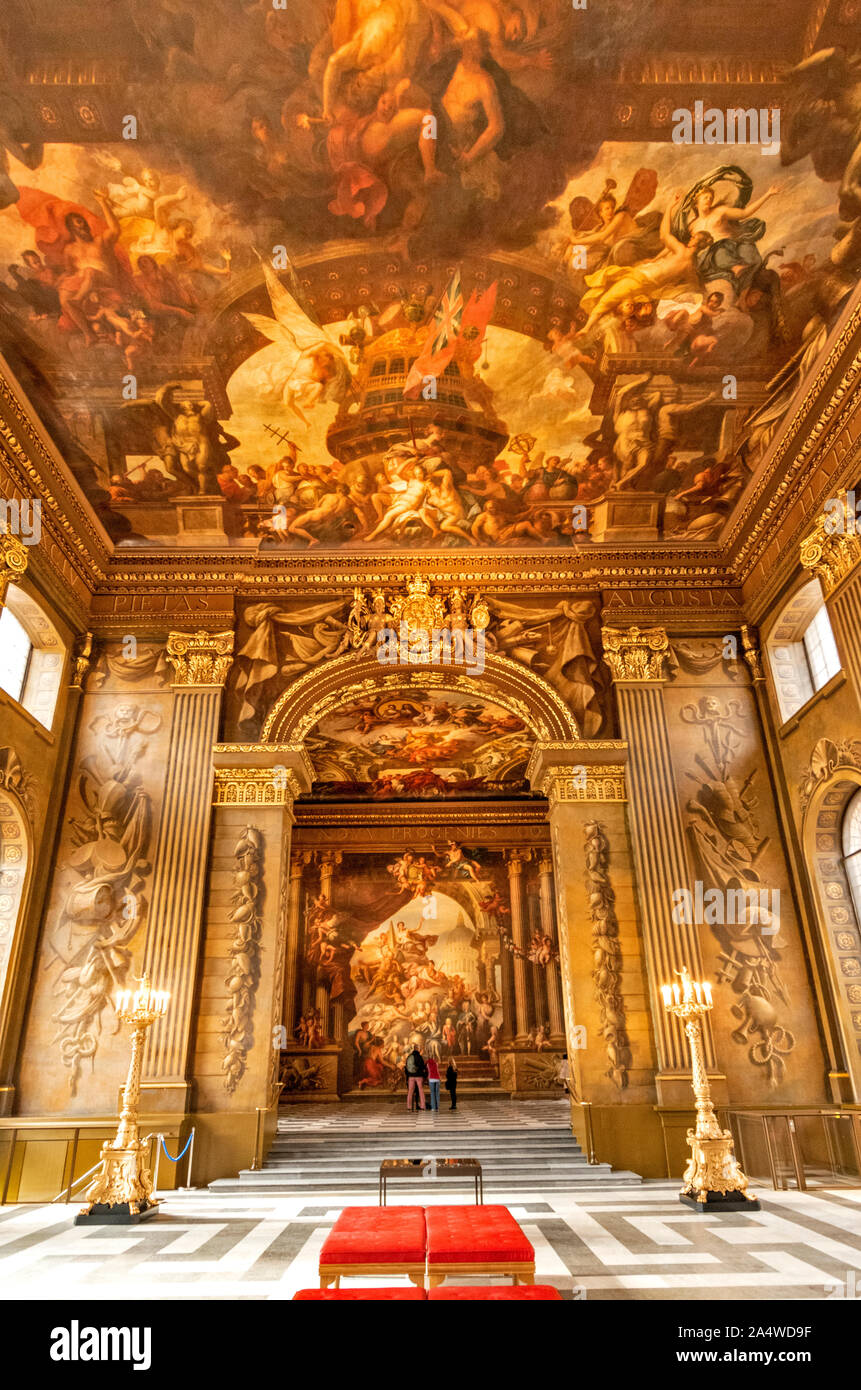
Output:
[259, 653, 579, 1094]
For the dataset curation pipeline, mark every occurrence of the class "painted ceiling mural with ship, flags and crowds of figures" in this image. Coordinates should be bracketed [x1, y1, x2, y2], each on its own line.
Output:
[0, 0, 861, 552]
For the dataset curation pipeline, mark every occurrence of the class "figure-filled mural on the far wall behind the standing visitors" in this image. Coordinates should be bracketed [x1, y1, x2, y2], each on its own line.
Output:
[291, 840, 558, 1091]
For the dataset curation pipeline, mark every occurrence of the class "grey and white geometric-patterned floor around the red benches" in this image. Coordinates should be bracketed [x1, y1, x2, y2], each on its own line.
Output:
[0, 1182, 861, 1301]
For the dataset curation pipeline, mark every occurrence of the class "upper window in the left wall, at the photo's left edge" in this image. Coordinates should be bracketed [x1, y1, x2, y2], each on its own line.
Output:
[0, 584, 65, 728]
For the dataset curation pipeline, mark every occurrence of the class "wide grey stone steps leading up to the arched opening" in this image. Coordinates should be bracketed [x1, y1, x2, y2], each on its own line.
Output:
[210, 1098, 641, 1202]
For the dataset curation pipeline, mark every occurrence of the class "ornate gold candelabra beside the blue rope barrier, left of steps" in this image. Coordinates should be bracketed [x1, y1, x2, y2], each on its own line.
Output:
[75, 974, 170, 1225]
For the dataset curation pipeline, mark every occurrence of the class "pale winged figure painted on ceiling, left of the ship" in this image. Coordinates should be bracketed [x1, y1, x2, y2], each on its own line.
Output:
[243, 252, 352, 425]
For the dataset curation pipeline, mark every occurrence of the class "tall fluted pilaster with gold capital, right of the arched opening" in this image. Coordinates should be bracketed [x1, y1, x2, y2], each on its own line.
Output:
[602, 627, 714, 1099]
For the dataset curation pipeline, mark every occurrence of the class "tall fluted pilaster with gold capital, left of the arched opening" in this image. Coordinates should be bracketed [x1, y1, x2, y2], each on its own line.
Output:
[143, 632, 234, 1111]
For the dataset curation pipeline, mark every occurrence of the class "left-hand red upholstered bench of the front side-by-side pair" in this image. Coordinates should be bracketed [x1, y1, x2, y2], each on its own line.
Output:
[320, 1207, 427, 1289]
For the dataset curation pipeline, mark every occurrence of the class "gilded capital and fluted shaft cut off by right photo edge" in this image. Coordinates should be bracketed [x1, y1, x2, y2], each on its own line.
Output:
[801, 493, 861, 705]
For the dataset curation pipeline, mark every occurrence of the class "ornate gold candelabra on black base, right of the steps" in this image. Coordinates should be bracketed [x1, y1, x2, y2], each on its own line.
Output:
[661, 966, 759, 1212]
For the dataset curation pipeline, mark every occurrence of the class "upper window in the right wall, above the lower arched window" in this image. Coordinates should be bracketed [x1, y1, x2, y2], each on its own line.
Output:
[766, 580, 840, 721]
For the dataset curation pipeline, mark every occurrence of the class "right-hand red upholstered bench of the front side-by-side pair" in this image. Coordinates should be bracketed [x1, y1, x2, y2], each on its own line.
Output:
[424, 1207, 536, 1289]
